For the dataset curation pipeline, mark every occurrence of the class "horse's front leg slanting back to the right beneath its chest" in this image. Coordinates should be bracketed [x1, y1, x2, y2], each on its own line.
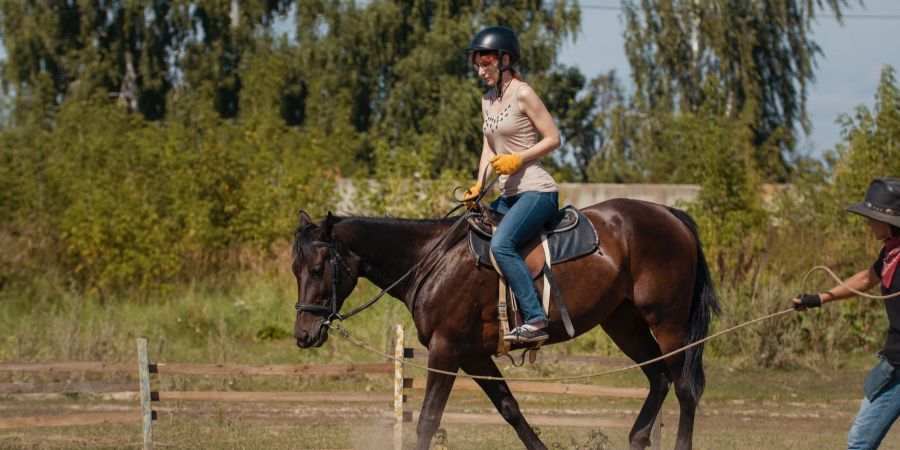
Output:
[462, 356, 547, 449]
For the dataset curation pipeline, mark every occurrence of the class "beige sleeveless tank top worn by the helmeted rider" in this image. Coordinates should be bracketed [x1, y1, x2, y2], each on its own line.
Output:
[481, 83, 559, 197]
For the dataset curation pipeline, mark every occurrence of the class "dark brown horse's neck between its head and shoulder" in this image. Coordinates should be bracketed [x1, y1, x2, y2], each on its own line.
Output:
[335, 218, 446, 301]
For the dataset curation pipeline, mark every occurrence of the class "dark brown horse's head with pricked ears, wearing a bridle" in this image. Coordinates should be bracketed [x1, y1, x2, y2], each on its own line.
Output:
[292, 211, 358, 348]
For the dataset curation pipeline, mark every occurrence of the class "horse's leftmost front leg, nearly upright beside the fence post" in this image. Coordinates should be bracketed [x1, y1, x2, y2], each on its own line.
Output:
[416, 337, 459, 450]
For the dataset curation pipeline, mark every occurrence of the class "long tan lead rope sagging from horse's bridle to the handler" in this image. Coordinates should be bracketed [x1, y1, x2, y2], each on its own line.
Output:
[329, 266, 900, 381]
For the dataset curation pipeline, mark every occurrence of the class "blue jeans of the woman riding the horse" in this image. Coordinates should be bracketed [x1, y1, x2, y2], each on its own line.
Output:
[491, 191, 559, 324]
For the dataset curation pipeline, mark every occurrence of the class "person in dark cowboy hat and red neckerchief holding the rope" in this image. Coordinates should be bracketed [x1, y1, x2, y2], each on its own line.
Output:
[793, 178, 900, 449]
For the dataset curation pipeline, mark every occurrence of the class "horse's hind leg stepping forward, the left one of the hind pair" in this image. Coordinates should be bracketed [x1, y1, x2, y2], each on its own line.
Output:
[601, 300, 671, 449]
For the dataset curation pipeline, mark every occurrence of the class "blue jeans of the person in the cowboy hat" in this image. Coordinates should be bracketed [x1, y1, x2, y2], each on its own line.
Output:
[847, 375, 900, 450]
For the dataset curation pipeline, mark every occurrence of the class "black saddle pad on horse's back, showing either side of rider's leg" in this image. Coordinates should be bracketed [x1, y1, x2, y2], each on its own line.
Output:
[469, 208, 599, 268]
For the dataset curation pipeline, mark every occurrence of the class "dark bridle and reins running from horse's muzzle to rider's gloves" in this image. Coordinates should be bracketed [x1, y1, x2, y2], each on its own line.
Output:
[294, 171, 500, 330]
